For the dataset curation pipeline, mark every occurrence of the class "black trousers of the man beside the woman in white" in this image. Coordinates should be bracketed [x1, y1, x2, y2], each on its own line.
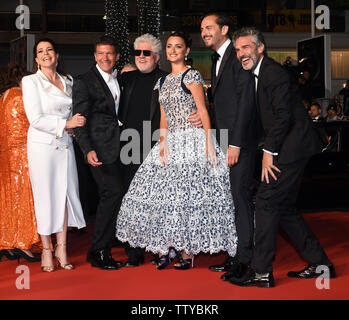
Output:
[89, 160, 123, 252]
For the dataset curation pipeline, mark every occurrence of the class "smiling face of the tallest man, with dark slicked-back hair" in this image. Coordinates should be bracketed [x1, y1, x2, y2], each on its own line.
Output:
[201, 15, 229, 51]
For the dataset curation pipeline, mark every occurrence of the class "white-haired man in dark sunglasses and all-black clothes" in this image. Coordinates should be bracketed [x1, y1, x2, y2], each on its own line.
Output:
[118, 33, 201, 267]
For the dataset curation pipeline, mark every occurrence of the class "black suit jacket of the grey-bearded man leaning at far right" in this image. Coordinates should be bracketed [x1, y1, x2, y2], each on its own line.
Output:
[257, 57, 320, 163]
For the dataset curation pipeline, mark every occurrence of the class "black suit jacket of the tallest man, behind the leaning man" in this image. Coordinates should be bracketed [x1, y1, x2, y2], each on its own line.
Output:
[211, 43, 258, 148]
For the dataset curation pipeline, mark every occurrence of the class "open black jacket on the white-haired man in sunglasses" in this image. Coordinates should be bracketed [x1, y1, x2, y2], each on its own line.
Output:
[119, 68, 168, 144]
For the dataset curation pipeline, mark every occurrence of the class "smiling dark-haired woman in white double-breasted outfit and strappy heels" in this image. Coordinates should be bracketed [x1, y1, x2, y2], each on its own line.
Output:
[22, 39, 86, 272]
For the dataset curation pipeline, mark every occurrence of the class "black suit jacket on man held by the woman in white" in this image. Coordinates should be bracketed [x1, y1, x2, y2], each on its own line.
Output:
[73, 66, 120, 164]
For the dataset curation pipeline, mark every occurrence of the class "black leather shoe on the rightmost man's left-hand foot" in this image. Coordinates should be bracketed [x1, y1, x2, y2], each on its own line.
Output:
[229, 268, 275, 288]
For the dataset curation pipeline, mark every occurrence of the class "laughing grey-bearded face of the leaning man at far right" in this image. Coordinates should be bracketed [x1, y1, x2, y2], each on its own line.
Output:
[235, 36, 264, 70]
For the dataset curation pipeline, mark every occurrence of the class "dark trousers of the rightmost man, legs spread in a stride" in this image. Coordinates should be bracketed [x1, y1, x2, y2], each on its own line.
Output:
[252, 159, 331, 273]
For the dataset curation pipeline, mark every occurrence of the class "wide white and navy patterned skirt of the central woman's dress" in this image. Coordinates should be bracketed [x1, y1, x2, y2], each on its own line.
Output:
[116, 128, 237, 256]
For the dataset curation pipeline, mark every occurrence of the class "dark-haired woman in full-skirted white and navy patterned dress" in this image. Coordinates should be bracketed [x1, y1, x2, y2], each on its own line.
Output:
[116, 32, 237, 270]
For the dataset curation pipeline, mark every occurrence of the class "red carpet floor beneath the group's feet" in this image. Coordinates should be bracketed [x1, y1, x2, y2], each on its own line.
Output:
[0, 212, 349, 300]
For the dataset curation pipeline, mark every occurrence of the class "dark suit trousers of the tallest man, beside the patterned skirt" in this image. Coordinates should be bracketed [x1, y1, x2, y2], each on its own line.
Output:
[230, 146, 257, 264]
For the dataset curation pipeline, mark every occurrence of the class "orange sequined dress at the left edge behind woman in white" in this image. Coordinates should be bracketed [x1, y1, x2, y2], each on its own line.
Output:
[0, 88, 40, 250]
